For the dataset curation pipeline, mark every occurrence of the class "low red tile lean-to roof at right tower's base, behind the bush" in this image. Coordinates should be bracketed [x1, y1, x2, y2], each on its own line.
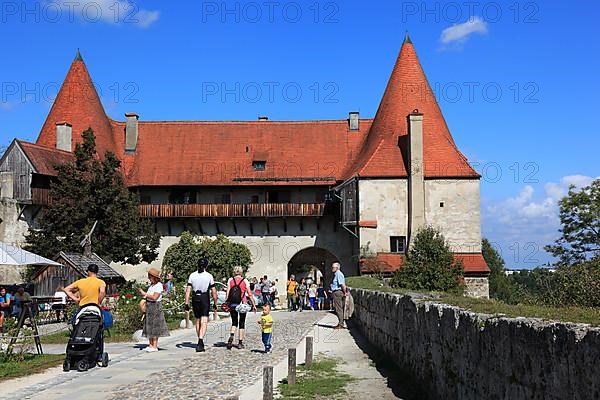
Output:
[360, 253, 490, 274]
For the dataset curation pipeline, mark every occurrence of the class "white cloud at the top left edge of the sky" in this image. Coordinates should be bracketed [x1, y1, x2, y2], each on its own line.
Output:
[50, 0, 160, 28]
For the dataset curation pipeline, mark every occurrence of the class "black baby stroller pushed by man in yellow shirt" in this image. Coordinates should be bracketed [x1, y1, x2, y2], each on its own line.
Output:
[63, 304, 108, 372]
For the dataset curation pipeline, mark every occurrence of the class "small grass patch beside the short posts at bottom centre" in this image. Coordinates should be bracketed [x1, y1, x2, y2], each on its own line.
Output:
[279, 358, 355, 400]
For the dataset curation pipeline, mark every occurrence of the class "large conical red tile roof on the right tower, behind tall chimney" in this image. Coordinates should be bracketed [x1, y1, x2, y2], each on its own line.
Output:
[345, 33, 479, 178]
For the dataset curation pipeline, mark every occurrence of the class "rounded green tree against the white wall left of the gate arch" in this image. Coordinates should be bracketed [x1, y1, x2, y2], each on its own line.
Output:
[163, 232, 252, 281]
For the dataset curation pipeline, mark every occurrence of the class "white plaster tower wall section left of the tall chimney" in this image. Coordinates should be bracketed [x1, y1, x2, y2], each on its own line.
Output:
[358, 179, 408, 252]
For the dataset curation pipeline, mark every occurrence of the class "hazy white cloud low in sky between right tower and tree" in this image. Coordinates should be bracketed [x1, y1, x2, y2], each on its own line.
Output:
[482, 175, 600, 268]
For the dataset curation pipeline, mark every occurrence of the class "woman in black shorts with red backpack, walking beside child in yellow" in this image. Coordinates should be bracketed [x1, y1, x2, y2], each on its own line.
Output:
[225, 265, 256, 350]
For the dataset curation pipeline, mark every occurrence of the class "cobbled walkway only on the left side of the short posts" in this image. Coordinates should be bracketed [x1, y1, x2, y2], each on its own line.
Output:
[0, 312, 324, 400]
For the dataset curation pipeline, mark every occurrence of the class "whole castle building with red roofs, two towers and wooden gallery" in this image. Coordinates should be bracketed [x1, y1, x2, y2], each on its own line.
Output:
[0, 35, 489, 296]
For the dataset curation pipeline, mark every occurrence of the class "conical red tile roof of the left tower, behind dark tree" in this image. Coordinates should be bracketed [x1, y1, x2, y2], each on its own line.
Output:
[36, 50, 115, 156]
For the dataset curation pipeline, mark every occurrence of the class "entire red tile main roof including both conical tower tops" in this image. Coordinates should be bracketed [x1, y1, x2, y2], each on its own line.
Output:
[29, 41, 479, 186]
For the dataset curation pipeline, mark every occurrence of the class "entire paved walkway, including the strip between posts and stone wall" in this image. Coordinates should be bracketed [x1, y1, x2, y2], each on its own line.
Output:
[0, 311, 408, 400]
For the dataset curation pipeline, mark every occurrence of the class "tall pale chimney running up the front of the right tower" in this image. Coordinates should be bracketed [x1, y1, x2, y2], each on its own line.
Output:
[407, 109, 425, 246]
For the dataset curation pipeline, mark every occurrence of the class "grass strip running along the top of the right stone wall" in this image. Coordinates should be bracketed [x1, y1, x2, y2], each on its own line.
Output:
[347, 276, 600, 326]
